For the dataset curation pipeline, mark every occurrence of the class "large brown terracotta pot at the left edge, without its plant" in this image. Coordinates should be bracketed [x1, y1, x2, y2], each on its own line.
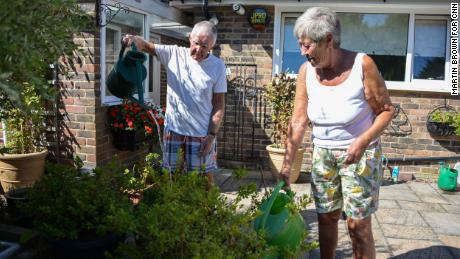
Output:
[0, 150, 48, 193]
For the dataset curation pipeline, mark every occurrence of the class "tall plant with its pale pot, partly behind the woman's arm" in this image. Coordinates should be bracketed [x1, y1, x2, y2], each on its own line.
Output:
[265, 72, 305, 183]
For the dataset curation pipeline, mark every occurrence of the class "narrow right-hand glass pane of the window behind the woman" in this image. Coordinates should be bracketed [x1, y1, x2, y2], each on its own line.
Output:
[413, 19, 447, 80]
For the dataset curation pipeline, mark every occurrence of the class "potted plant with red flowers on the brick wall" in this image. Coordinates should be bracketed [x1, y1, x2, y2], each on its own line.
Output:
[107, 99, 164, 151]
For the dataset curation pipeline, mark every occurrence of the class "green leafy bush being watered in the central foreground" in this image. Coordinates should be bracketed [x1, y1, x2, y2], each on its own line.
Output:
[111, 155, 312, 258]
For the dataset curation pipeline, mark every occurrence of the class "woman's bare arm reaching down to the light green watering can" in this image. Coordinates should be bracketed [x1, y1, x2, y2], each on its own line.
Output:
[280, 64, 308, 186]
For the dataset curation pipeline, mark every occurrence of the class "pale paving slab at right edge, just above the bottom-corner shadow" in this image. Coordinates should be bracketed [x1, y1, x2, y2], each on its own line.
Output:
[420, 211, 460, 236]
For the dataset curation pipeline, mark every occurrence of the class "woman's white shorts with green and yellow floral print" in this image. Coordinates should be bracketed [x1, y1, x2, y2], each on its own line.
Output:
[311, 144, 383, 219]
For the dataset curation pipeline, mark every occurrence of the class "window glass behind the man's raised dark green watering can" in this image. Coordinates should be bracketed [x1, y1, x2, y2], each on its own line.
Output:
[105, 7, 144, 96]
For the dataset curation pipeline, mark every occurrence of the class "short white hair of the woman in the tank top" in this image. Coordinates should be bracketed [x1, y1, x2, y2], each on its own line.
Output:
[294, 7, 340, 47]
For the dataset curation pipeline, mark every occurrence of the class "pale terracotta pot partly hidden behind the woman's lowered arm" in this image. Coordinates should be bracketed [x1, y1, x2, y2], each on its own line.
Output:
[266, 145, 305, 183]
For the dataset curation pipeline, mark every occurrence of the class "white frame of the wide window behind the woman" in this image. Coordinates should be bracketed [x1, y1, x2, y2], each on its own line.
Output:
[272, 2, 451, 93]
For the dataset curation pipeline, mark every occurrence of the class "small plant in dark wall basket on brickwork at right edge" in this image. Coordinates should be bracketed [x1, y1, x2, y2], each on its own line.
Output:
[427, 107, 460, 136]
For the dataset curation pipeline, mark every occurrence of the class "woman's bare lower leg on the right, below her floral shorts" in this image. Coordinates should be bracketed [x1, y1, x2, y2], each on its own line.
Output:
[347, 216, 375, 259]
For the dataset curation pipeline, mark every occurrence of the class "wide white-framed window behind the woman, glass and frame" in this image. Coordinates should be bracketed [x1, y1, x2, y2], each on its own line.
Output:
[274, 7, 450, 92]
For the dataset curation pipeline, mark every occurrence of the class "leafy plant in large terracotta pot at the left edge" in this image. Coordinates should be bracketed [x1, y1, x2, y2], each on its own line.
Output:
[0, 83, 48, 194]
